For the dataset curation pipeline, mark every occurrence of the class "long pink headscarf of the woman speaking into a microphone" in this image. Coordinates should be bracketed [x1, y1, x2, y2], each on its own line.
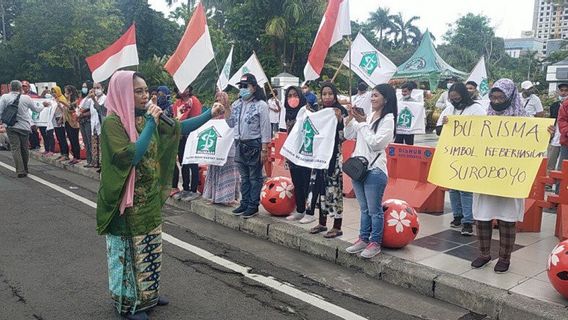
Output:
[105, 71, 138, 215]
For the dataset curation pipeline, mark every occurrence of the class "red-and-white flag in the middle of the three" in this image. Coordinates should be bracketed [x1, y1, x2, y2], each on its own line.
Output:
[165, 2, 215, 91]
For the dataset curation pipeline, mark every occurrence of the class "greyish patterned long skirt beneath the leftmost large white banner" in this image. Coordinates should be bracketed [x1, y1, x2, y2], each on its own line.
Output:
[203, 157, 240, 204]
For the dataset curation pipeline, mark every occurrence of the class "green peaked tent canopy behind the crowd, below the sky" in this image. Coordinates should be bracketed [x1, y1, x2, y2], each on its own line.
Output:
[393, 30, 467, 90]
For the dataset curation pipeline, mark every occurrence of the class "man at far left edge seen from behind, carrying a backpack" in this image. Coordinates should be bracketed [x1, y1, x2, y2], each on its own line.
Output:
[0, 80, 43, 178]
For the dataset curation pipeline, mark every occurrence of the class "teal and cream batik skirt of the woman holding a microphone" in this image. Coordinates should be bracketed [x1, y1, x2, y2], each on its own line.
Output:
[106, 225, 162, 315]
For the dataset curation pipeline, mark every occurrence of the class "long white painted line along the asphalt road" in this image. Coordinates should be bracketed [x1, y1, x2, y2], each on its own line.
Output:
[0, 161, 367, 320]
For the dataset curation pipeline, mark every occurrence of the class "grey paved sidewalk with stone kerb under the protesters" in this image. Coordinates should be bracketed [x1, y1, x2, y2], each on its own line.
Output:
[27, 140, 568, 319]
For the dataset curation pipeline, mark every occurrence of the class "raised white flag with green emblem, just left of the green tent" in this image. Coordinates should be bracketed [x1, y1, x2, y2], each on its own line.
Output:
[343, 33, 396, 87]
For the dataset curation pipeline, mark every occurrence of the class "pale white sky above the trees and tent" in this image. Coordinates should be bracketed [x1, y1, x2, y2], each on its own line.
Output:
[148, 0, 534, 39]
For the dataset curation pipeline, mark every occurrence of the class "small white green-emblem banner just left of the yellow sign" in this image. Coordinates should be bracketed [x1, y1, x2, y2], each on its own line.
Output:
[396, 100, 426, 134]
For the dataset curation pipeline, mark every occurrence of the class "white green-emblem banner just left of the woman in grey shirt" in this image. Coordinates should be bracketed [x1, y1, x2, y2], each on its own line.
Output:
[182, 119, 235, 166]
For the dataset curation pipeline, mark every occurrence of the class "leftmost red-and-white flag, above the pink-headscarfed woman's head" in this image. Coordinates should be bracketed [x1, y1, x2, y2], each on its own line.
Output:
[86, 24, 138, 82]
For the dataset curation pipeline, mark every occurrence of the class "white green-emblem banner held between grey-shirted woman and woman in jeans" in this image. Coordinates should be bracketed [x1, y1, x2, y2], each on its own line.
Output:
[280, 108, 337, 169]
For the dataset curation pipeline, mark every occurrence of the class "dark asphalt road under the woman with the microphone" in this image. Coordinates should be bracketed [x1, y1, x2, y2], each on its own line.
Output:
[0, 152, 483, 320]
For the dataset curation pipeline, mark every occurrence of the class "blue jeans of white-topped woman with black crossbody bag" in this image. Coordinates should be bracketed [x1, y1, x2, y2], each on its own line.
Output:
[353, 168, 387, 244]
